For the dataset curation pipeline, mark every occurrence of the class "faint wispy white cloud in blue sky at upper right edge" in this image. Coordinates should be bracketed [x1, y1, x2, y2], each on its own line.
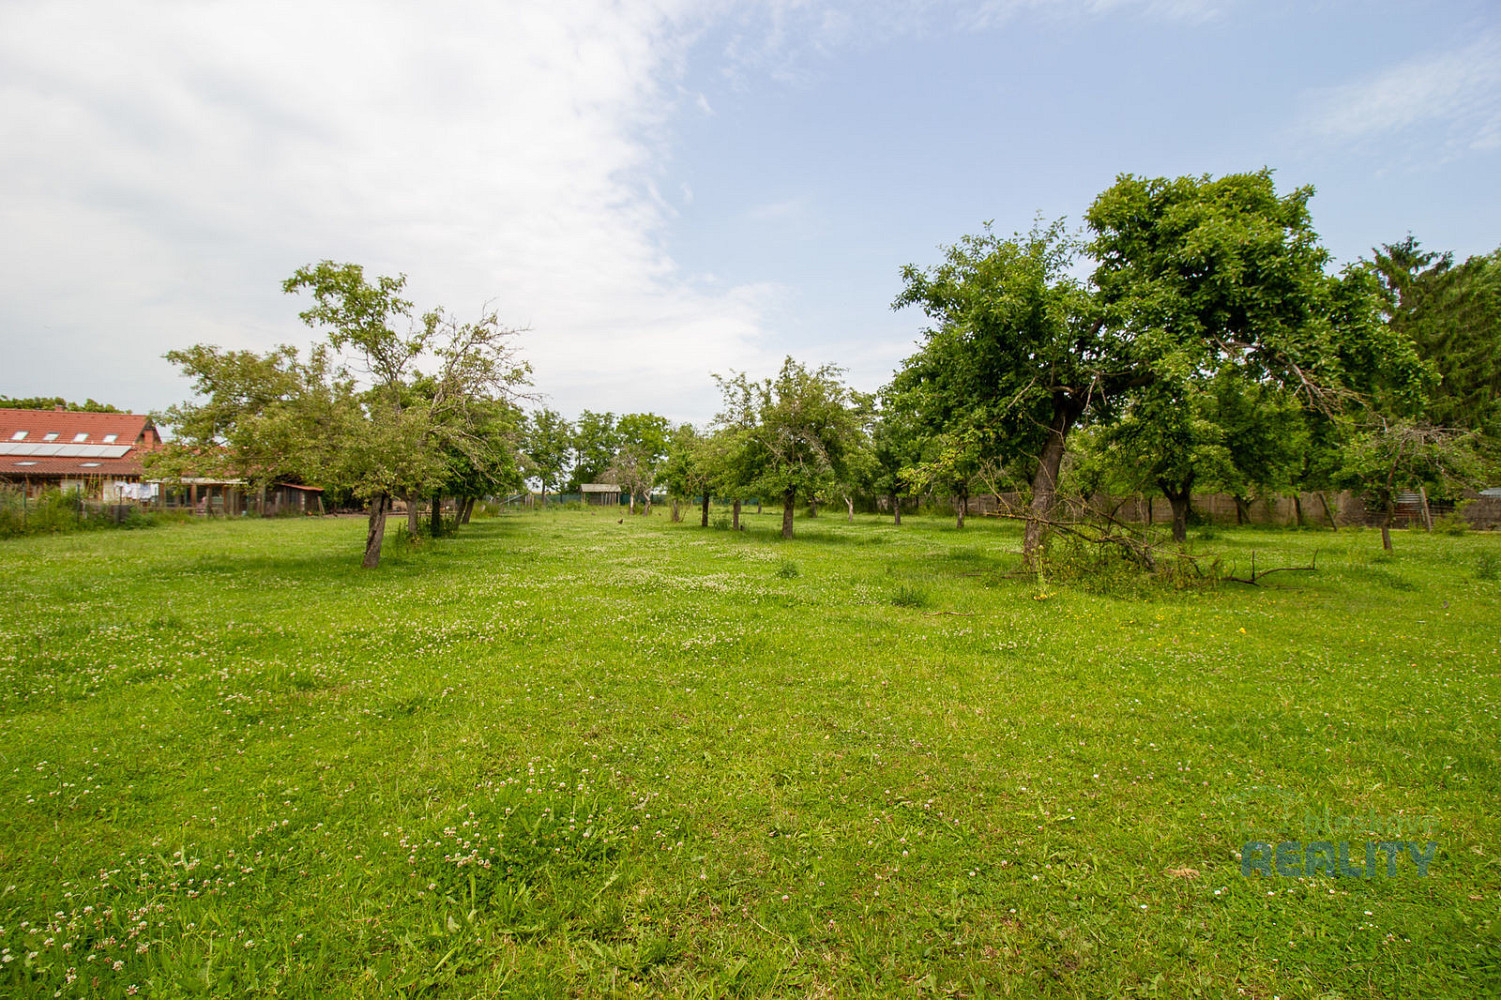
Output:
[1303, 32, 1501, 158]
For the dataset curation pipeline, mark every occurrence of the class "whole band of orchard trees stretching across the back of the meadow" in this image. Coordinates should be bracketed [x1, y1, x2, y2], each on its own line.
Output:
[156, 171, 1501, 566]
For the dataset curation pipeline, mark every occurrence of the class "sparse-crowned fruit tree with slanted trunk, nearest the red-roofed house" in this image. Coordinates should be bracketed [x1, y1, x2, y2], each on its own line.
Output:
[146, 261, 530, 566]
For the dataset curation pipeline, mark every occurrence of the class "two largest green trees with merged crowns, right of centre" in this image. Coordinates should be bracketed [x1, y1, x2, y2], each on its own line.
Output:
[893, 170, 1398, 559]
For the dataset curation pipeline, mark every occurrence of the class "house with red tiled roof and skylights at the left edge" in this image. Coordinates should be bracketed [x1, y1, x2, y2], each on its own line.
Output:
[0, 410, 162, 500]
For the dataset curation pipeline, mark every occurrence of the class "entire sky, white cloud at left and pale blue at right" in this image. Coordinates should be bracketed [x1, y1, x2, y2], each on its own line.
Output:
[0, 0, 1501, 420]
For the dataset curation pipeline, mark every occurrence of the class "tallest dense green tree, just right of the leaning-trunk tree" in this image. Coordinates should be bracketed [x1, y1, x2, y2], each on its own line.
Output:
[1087, 171, 1424, 539]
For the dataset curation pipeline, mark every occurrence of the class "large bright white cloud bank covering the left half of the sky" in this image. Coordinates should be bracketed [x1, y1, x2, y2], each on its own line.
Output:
[0, 0, 767, 416]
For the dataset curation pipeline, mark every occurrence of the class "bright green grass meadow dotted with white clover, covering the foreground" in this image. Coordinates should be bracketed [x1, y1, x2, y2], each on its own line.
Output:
[0, 509, 1501, 998]
